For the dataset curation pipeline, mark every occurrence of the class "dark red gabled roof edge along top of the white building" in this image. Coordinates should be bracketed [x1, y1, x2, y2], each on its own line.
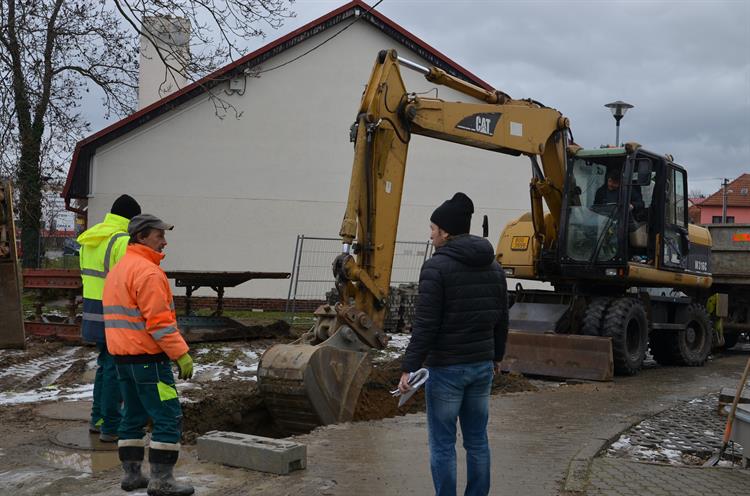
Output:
[62, 0, 493, 200]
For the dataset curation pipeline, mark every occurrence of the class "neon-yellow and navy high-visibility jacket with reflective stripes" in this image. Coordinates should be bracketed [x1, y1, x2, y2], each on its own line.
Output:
[78, 213, 130, 343]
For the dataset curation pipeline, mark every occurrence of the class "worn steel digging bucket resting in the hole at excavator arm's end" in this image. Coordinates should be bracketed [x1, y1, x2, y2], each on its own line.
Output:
[258, 344, 371, 434]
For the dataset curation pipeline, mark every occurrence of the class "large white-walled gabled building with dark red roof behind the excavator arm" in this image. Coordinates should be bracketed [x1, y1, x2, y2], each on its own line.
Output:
[63, 1, 530, 298]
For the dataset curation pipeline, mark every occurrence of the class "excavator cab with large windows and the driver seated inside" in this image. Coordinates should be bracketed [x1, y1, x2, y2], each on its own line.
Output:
[560, 144, 710, 286]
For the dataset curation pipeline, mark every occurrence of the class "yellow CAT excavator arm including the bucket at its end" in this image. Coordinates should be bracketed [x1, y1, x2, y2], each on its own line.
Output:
[258, 50, 569, 432]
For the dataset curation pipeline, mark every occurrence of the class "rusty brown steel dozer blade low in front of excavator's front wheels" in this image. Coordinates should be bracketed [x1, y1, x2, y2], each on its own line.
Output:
[500, 331, 614, 381]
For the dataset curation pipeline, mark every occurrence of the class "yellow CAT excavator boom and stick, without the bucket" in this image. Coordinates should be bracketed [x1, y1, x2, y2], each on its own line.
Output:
[334, 50, 569, 341]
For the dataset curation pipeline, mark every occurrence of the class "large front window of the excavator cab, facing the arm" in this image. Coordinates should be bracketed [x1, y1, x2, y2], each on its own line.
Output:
[562, 155, 628, 263]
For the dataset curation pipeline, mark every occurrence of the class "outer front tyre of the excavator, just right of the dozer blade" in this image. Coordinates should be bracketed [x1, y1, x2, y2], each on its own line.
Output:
[602, 297, 648, 375]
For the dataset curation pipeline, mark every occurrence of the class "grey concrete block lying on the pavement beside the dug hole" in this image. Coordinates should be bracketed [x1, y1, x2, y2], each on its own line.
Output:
[198, 431, 307, 475]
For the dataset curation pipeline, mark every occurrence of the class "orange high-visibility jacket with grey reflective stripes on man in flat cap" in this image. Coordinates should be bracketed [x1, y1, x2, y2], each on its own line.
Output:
[102, 244, 188, 360]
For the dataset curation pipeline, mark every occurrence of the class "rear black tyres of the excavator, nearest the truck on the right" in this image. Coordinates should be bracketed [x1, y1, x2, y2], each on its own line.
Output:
[651, 303, 713, 367]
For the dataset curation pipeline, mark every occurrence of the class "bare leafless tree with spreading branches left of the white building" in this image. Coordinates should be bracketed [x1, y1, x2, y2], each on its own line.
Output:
[0, 0, 294, 267]
